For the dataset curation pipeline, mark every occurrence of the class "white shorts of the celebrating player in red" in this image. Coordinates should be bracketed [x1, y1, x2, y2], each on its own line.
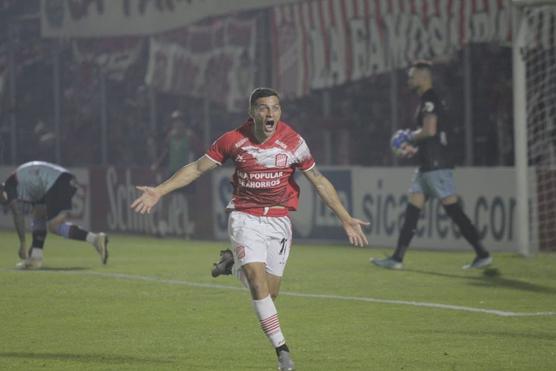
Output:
[228, 211, 292, 277]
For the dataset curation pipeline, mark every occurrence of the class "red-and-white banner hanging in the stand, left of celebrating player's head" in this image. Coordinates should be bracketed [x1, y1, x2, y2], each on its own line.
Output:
[145, 17, 257, 111]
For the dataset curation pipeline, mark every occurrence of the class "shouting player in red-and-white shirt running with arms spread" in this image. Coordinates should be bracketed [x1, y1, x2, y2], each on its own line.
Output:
[131, 88, 368, 370]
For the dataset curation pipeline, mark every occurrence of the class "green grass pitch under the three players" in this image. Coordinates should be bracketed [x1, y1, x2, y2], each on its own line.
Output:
[0, 231, 556, 371]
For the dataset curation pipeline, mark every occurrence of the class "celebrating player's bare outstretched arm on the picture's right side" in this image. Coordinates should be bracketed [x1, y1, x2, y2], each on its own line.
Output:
[304, 167, 369, 246]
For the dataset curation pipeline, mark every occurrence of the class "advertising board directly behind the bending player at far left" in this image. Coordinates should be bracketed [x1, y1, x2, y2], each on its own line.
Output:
[0, 166, 91, 231]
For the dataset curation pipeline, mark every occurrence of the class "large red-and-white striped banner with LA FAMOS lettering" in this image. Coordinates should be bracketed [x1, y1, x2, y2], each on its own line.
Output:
[272, 0, 512, 98]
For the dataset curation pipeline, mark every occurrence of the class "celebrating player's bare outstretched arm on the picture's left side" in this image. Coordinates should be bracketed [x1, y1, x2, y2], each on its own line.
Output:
[131, 156, 218, 214]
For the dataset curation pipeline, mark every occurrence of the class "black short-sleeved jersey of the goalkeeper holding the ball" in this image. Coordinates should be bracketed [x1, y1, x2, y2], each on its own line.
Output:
[416, 89, 454, 172]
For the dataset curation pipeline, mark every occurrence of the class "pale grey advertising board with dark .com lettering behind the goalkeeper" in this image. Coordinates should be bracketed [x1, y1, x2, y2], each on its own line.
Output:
[352, 167, 517, 251]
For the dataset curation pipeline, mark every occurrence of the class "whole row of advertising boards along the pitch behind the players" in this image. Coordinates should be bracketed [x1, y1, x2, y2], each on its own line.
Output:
[0, 166, 516, 251]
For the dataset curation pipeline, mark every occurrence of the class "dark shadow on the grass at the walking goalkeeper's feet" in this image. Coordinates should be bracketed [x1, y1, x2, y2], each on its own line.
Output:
[405, 268, 556, 295]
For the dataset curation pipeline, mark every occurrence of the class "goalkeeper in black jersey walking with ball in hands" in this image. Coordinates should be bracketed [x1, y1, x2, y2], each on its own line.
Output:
[371, 62, 492, 269]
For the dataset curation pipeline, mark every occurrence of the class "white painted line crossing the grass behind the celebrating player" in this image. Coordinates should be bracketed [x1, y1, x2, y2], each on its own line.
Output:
[5, 269, 556, 317]
